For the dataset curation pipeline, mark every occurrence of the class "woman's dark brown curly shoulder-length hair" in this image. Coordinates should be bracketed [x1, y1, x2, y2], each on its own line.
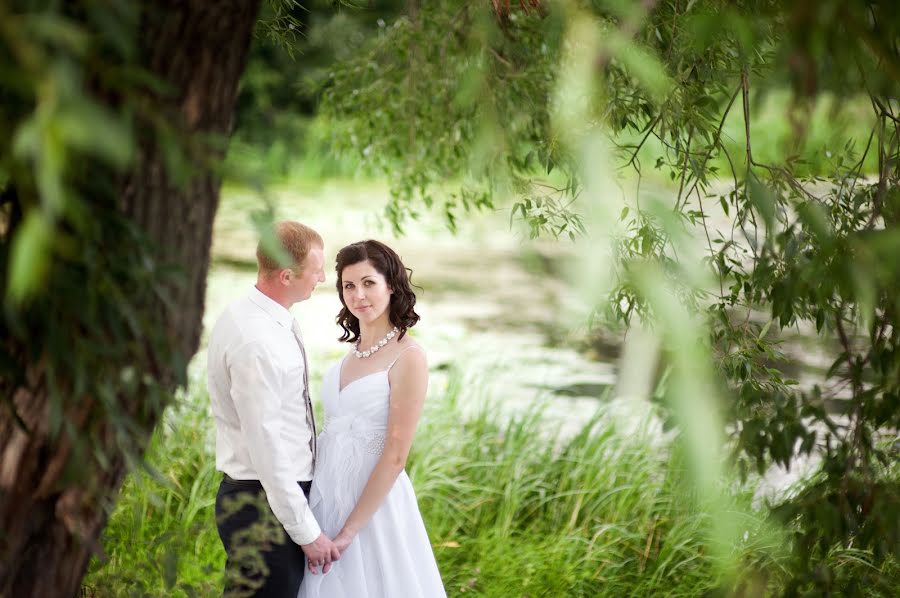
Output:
[334, 239, 419, 343]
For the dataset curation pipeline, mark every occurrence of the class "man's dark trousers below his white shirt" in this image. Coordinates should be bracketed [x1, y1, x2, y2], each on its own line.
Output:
[216, 476, 311, 598]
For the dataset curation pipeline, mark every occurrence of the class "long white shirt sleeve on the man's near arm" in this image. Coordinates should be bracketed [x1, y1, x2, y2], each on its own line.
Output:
[228, 341, 322, 545]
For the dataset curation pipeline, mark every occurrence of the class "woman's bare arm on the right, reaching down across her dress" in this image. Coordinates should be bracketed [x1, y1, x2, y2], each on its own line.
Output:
[334, 348, 428, 551]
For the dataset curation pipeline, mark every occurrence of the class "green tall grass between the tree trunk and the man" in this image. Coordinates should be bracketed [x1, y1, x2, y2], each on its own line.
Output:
[84, 392, 225, 597]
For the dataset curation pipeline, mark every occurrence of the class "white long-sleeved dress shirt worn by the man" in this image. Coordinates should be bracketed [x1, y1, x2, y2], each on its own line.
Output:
[207, 287, 321, 544]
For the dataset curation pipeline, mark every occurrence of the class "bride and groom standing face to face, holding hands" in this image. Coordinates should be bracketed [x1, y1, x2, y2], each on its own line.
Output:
[208, 221, 446, 598]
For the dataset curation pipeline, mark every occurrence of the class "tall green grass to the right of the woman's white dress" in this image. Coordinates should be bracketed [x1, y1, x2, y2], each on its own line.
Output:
[410, 379, 779, 596]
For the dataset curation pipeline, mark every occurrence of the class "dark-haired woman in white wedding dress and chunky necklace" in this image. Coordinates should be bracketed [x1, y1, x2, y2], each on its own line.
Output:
[299, 241, 446, 598]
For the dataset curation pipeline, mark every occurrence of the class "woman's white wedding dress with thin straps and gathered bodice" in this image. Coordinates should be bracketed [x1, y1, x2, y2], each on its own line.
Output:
[299, 352, 446, 598]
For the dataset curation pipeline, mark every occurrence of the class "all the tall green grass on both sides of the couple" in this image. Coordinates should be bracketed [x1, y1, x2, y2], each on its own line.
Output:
[85, 375, 796, 597]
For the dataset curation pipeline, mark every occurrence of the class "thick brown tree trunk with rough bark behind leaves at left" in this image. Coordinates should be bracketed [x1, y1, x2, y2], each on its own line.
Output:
[0, 0, 259, 598]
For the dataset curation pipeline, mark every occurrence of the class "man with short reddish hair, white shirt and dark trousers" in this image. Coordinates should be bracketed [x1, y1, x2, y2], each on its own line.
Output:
[208, 221, 340, 598]
